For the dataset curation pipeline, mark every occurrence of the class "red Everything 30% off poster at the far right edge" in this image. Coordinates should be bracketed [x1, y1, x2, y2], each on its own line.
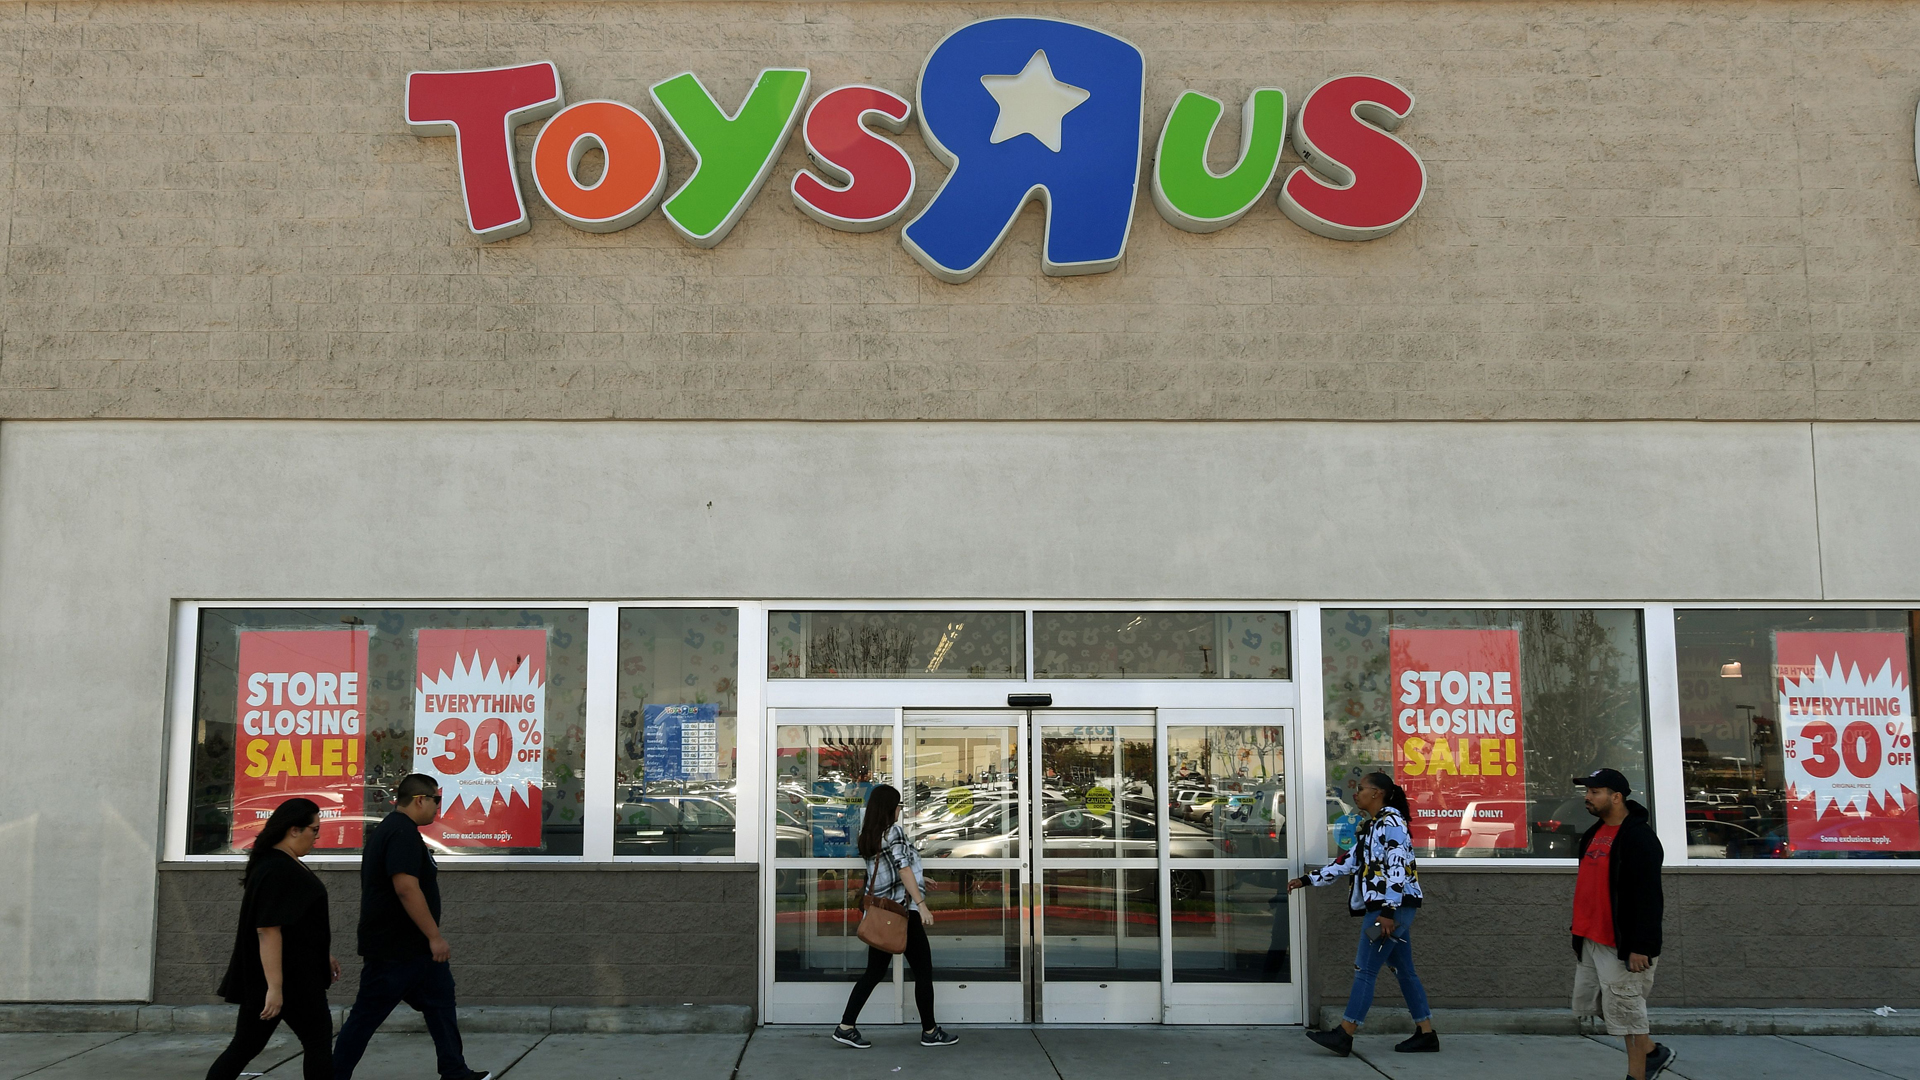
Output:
[1774, 630, 1920, 851]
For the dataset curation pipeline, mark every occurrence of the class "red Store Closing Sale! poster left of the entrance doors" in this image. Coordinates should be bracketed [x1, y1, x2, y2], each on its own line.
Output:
[230, 628, 367, 847]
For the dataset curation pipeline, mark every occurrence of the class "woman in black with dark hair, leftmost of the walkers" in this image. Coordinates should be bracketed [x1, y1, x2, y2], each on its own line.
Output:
[207, 799, 340, 1080]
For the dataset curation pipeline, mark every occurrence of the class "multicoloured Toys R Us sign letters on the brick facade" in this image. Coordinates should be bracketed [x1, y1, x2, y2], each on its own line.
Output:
[407, 17, 1427, 284]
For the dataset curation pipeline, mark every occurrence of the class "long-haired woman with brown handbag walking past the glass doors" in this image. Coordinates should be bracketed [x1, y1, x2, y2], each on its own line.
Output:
[833, 784, 960, 1049]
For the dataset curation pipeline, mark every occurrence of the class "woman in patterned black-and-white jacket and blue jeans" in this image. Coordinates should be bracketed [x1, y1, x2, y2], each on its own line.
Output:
[1286, 773, 1440, 1057]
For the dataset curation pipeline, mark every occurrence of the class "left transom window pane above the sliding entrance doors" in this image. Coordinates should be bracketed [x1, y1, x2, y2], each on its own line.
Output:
[766, 611, 1027, 678]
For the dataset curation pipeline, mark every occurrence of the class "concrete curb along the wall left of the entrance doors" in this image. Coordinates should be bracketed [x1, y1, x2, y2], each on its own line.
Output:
[0, 1003, 753, 1036]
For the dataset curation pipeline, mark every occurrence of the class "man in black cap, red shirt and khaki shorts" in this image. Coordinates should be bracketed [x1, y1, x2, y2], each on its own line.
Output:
[1572, 769, 1674, 1080]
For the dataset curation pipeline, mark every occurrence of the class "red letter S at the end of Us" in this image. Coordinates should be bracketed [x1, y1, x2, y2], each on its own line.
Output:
[1281, 75, 1427, 240]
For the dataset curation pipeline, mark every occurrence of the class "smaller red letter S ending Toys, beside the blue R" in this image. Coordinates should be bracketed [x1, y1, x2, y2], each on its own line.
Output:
[793, 86, 914, 233]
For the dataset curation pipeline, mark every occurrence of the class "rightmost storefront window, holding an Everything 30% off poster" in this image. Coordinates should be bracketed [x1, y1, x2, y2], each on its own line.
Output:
[1674, 611, 1920, 859]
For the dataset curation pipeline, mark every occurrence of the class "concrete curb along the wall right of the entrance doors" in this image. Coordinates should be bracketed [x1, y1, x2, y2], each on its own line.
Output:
[1319, 1005, 1920, 1036]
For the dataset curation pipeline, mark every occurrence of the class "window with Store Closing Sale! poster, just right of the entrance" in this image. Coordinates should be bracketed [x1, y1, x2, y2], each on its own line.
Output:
[1323, 607, 1653, 857]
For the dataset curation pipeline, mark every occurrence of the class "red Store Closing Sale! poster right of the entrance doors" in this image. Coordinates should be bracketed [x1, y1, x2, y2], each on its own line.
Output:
[1388, 628, 1528, 847]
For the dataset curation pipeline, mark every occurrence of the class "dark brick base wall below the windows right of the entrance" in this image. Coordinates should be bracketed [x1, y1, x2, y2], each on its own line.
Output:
[1308, 863, 1920, 1015]
